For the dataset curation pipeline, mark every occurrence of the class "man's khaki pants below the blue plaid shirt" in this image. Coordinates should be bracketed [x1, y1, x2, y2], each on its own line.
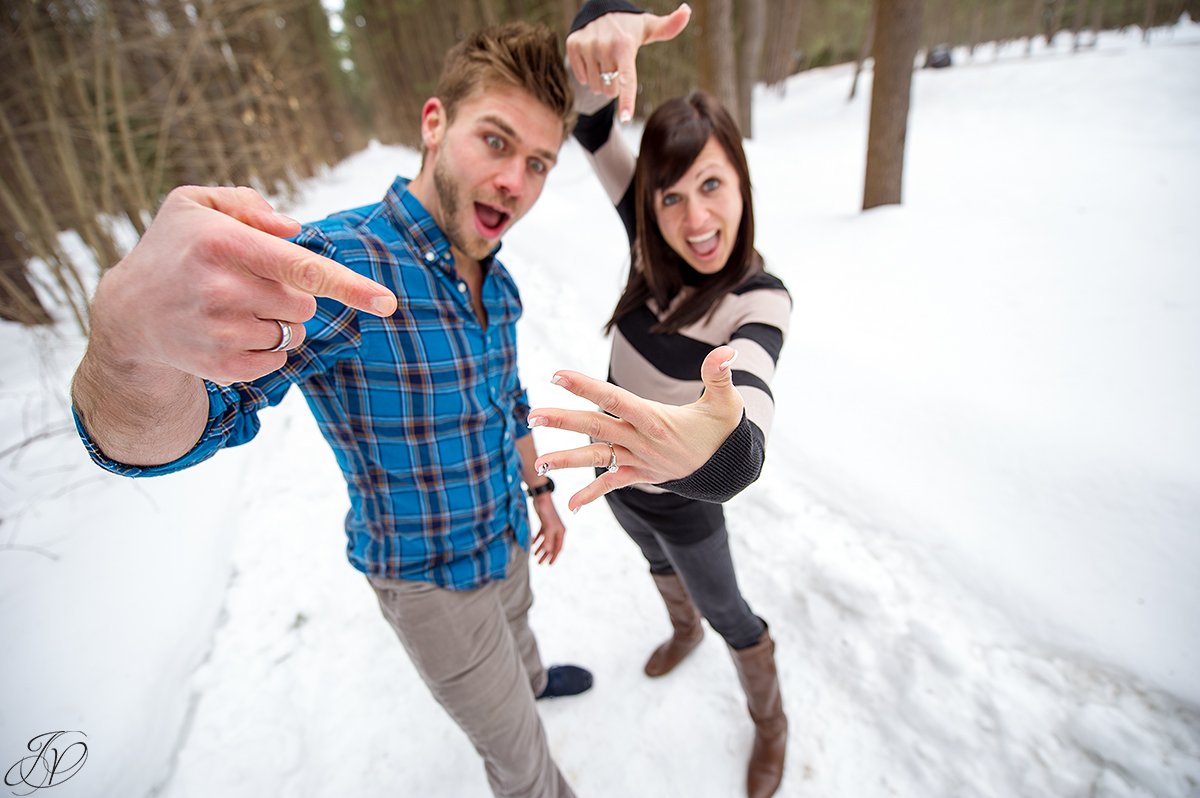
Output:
[368, 545, 575, 798]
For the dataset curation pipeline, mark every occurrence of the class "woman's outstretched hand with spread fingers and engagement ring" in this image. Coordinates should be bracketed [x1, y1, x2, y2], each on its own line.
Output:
[529, 347, 744, 512]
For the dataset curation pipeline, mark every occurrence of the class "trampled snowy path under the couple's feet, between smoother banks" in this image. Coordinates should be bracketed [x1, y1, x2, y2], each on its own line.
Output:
[150, 393, 1200, 798]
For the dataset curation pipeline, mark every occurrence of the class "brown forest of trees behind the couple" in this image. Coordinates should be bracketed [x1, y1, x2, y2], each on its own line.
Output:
[0, 0, 1200, 331]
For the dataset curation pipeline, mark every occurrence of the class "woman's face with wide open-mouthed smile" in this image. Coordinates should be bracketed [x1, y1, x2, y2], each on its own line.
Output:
[654, 136, 742, 275]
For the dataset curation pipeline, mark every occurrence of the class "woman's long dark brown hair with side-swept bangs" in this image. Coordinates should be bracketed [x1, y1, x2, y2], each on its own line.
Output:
[605, 91, 762, 332]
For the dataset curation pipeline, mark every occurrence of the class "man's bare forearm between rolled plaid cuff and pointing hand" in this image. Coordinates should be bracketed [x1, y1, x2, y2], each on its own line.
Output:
[71, 342, 209, 466]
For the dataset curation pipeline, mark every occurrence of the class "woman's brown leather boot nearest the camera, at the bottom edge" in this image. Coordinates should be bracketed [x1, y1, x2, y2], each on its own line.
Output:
[730, 631, 787, 798]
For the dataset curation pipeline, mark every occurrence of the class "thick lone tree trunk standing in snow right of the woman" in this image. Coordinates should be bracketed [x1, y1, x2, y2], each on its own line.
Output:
[863, 0, 920, 210]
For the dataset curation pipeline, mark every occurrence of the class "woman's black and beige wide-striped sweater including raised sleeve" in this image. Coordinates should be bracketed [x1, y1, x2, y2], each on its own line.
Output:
[575, 78, 792, 502]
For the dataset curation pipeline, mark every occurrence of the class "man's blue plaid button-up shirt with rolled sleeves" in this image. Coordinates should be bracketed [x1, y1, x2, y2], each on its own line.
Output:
[77, 178, 529, 589]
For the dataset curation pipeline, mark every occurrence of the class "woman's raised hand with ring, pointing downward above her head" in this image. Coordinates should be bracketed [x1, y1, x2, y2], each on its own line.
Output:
[566, 2, 691, 122]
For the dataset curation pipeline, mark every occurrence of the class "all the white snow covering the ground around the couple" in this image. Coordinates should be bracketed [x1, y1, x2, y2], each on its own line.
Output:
[0, 24, 1200, 798]
